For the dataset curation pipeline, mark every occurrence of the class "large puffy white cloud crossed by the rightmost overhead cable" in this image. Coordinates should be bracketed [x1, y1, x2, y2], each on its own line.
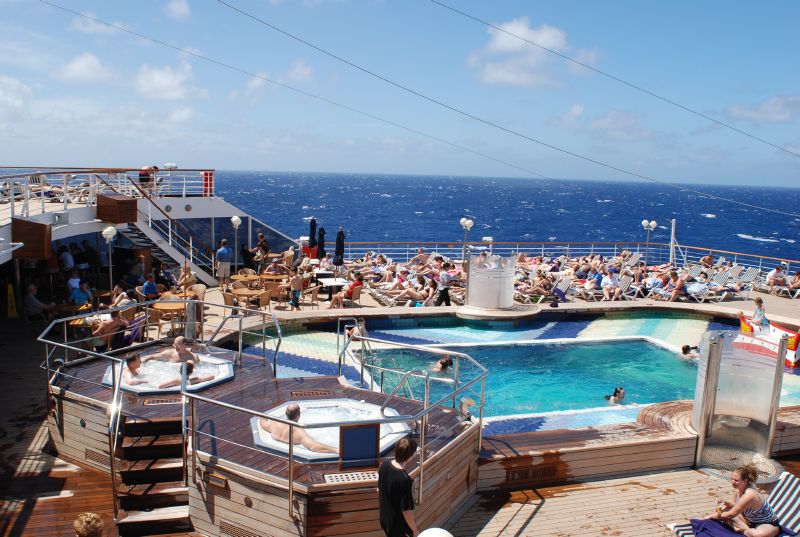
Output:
[468, 17, 596, 87]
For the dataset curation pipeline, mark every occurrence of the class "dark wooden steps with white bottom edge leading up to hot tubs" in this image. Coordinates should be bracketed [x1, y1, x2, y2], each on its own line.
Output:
[114, 418, 192, 536]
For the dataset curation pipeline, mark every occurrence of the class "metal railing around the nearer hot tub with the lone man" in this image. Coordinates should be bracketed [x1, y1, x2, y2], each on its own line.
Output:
[181, 338, 488, 518]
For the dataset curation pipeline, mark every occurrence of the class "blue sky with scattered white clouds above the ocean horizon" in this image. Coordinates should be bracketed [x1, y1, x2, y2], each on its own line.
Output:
[0, 0, 800, 186]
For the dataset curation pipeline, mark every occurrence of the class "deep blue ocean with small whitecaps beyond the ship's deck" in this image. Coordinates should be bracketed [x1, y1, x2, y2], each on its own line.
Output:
[216, 171, 800, 259]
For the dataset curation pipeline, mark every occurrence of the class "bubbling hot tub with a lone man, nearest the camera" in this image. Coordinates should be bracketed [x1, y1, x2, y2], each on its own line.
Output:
[250, 398, 411, 462]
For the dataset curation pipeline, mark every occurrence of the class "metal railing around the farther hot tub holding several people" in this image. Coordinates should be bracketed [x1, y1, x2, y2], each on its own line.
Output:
[37, 300, 282, 518]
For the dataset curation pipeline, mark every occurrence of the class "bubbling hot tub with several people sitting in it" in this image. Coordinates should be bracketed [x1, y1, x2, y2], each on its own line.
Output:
[103, 354, 233, 395]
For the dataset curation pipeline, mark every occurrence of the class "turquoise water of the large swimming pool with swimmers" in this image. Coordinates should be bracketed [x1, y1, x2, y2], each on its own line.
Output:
[376, 341, 697, 416]
